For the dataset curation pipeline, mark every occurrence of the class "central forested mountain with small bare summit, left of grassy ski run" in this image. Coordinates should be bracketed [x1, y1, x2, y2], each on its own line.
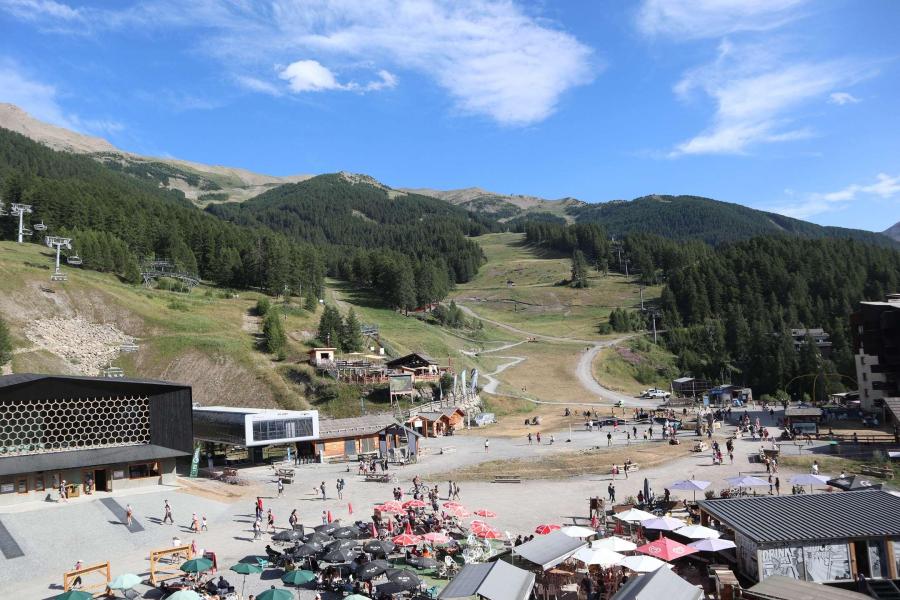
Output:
[207, 173, 501, 309]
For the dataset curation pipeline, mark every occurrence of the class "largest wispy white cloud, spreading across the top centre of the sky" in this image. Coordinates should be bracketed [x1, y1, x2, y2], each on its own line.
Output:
[0, 0, 601, 125]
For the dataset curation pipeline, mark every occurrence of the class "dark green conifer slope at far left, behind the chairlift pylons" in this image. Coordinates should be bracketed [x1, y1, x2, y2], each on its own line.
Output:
[0, 129, 325, 297]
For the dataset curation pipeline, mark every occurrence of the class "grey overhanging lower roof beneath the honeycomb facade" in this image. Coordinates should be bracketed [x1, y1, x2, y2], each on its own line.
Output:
[0, 444, 190, 476]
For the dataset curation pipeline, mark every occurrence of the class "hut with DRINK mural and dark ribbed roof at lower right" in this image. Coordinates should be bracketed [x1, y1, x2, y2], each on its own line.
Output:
[699, 490, 900, 585]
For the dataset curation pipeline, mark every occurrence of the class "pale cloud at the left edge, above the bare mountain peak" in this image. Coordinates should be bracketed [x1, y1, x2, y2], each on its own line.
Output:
[0, 59, 125, 135]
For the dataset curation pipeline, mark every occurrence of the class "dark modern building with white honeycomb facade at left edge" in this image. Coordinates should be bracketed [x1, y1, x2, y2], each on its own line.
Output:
[0, 374, 193, 505]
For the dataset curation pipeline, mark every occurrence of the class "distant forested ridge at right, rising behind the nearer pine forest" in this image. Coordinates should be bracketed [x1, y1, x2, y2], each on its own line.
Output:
[567, 195, 894, 245]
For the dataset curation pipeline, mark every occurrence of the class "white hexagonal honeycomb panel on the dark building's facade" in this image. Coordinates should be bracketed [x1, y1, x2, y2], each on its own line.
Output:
[0, 397, 150, 456]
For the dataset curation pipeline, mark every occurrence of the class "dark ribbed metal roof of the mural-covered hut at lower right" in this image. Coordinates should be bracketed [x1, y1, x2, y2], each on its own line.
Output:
[700, 490, 900, 543]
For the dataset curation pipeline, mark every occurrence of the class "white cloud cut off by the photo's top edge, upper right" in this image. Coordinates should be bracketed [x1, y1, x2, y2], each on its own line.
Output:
[637, 0, 806, 38]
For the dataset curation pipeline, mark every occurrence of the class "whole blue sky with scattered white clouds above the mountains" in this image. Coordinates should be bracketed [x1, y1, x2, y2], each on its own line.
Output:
[0, 0, 900, 230]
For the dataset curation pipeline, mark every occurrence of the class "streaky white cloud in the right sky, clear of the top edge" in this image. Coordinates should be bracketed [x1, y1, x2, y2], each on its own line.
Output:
[671, 41, 865, 156]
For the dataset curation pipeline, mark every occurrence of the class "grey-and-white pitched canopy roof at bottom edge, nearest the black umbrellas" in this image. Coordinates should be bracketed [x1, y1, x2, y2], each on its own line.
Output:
[438, 560, 534, 600]
